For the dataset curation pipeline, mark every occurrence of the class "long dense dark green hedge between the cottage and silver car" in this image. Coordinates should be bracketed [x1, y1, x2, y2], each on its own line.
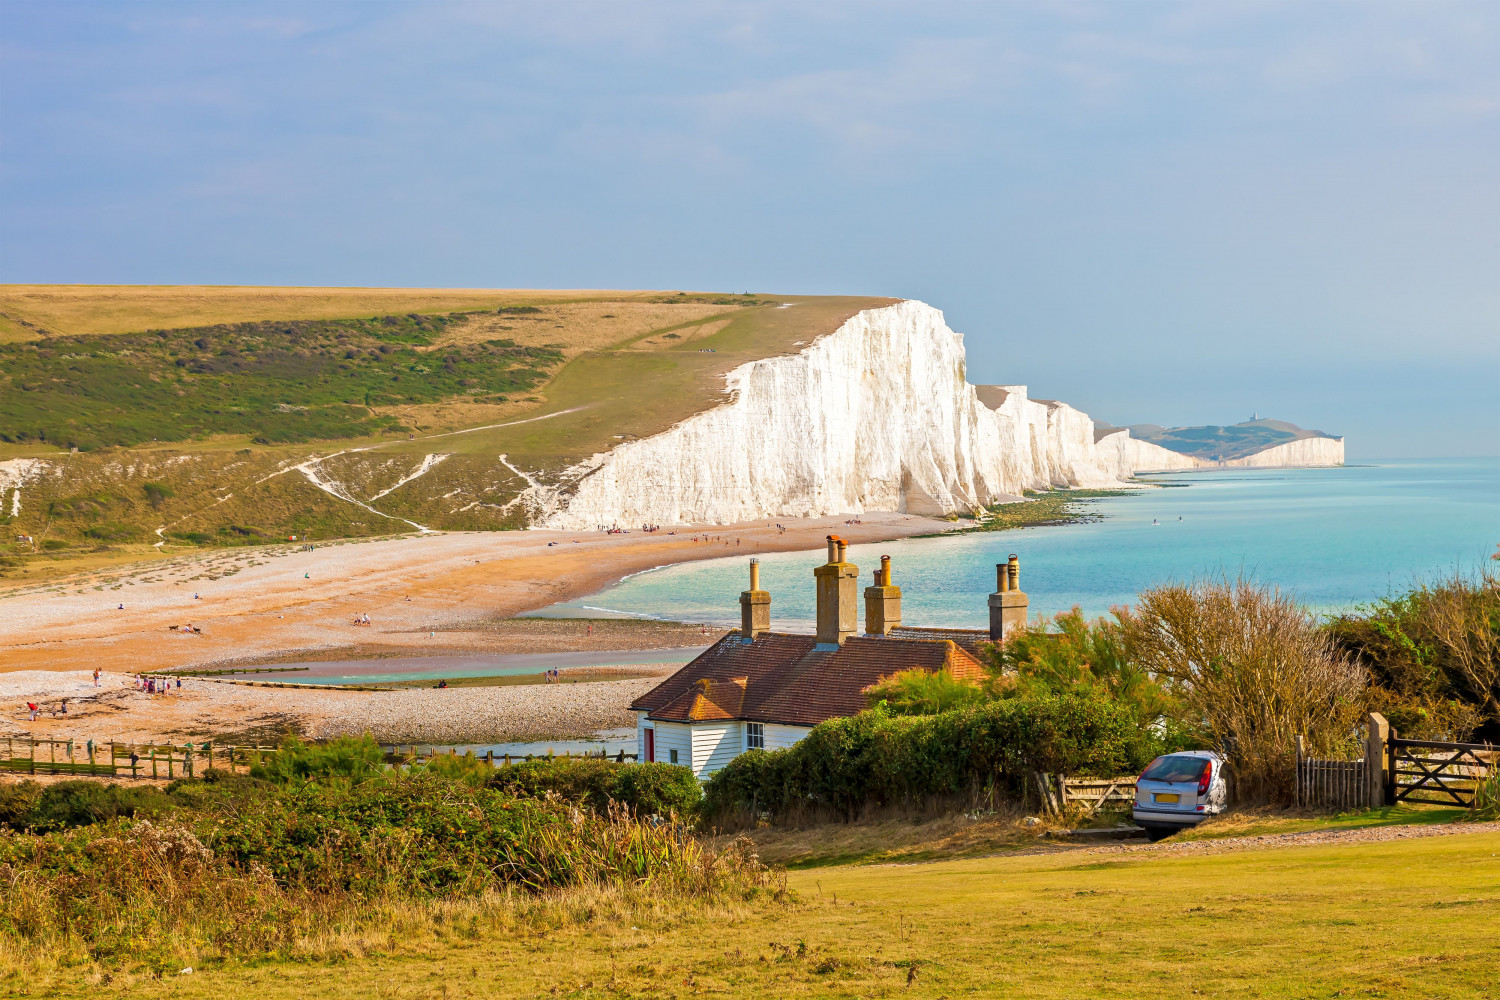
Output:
[704, 696, 1179, 819]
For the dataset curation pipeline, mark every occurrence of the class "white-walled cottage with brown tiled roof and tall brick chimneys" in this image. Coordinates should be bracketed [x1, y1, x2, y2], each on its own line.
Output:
[630, 535, 1028, 778]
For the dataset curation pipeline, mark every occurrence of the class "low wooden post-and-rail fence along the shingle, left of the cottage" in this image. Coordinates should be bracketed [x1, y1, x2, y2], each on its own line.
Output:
[0, 736, 636, 780]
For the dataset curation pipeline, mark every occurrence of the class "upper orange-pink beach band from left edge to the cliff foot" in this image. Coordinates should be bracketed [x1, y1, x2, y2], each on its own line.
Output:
[0, 513, 954, 676]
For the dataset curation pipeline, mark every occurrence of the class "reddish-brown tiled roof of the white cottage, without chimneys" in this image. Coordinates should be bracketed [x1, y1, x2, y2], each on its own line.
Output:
[630, 633, 984, 726]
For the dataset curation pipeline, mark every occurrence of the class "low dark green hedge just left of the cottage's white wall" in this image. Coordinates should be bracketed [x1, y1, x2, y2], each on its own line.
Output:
[489, 757, 704, 817]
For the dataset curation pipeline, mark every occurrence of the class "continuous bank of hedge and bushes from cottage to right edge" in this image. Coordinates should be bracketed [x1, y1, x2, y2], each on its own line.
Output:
[705, 568, 1500, 826]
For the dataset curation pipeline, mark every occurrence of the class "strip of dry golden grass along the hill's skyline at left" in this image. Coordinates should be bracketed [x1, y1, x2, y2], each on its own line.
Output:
[0, 285, 662, 340]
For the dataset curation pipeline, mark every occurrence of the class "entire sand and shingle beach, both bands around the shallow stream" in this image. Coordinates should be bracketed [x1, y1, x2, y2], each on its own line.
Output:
[0, 514, 951, 742]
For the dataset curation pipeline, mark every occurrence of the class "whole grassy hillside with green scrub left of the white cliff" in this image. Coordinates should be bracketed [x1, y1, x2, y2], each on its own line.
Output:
[0, 285, 893, 576]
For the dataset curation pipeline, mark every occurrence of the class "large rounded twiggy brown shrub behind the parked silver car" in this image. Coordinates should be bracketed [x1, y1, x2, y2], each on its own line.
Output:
[1118, 579, 1365, 799]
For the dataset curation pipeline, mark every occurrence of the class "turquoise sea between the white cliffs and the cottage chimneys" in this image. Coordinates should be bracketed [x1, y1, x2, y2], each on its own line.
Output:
[545, 459, 1500, 631]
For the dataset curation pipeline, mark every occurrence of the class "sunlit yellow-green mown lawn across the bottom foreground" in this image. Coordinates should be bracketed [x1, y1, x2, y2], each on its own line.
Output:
[58, 834, 1500, 1000]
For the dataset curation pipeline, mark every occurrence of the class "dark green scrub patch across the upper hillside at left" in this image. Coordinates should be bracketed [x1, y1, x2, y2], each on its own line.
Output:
[0, 313, 563, 449]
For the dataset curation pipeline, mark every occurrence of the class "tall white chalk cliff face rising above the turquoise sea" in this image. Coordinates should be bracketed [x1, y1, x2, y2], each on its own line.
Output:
[540, 301, 1343, 529]
